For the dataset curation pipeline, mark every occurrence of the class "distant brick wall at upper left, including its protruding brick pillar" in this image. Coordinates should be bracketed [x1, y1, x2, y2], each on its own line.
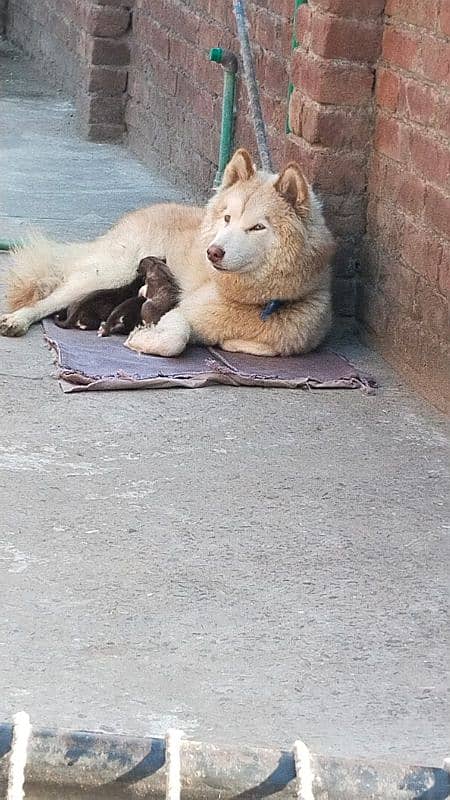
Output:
[7, 0, 131, 139]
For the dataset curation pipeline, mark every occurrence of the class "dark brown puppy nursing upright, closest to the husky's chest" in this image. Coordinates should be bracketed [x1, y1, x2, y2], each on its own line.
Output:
[138, 256, 179, 325]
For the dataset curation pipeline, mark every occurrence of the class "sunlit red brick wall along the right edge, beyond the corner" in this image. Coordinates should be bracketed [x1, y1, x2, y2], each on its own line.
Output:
[359, 0, 450, 410]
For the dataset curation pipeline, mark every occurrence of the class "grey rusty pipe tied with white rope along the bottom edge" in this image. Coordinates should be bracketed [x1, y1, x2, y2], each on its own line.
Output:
[0, 725, 450, 800]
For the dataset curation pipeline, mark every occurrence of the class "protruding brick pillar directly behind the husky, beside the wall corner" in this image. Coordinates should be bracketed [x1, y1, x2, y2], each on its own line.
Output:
[285, 0, 384, 319]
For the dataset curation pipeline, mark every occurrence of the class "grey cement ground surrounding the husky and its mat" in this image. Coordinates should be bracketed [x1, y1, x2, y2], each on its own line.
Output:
[0, 39, 450, 766]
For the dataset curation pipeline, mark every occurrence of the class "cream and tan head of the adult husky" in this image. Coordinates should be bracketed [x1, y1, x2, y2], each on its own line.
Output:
[203, 149, 321, 273]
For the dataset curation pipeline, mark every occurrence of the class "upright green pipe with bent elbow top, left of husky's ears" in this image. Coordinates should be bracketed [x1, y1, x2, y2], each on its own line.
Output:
[209, 47, 238, 187]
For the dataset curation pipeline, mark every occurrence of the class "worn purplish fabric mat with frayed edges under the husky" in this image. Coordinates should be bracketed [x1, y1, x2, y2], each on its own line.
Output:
[43, 319, 376, 392]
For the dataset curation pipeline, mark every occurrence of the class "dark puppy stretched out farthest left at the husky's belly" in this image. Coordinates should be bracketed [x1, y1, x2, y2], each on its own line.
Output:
[54, 274, 144, 331]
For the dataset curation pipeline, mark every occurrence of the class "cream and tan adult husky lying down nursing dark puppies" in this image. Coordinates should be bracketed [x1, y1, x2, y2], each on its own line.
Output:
[0, 149, 334, 356]
